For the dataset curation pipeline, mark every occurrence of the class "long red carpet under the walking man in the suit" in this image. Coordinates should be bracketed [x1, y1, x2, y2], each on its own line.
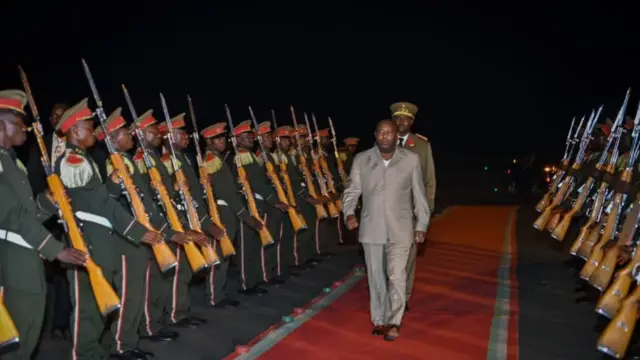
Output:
[260, 207, 518, 360]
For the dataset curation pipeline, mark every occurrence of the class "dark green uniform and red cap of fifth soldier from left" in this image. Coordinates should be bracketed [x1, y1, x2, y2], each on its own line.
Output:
[158, 113, 215, 323]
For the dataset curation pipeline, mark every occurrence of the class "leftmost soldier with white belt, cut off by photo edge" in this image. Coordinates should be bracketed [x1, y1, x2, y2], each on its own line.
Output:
[0, 90, 87, 360]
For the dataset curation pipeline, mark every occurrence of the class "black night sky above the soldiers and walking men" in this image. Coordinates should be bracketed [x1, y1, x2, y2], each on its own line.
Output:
[0, 1, 640, 165]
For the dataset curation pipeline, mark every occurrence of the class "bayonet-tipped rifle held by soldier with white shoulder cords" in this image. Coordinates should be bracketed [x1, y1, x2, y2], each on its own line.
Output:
[82, 59, 178, 272]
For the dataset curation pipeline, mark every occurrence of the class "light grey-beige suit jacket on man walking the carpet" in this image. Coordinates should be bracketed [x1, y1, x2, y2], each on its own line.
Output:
[342, 146, 431, 244]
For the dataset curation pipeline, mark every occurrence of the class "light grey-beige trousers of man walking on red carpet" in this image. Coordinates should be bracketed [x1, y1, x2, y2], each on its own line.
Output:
[362, 243, 412, 326]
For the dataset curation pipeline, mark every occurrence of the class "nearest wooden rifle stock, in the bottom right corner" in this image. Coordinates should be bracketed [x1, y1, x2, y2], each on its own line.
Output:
[598, 286, 640, 359]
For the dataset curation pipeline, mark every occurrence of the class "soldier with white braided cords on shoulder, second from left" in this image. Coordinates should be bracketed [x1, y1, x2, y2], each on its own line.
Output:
[45, 99, 163, 359]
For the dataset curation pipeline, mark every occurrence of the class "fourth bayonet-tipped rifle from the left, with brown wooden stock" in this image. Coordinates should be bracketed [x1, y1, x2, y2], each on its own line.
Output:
[160, 93, 220, 266]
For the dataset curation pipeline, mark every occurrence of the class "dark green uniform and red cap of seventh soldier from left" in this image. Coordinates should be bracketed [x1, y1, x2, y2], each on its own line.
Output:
[228, 120, 277, 290]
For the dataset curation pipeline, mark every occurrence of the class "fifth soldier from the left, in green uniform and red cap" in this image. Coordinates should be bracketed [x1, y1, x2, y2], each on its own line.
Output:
[158, 113, 224, 327]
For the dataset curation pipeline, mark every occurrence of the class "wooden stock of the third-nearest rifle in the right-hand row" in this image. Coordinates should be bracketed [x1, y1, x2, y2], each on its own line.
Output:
[589, 169, 637, 291]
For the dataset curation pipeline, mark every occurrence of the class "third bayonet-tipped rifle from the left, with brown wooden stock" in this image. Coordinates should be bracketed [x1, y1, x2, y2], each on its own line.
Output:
[122, 85, 207, 273]
